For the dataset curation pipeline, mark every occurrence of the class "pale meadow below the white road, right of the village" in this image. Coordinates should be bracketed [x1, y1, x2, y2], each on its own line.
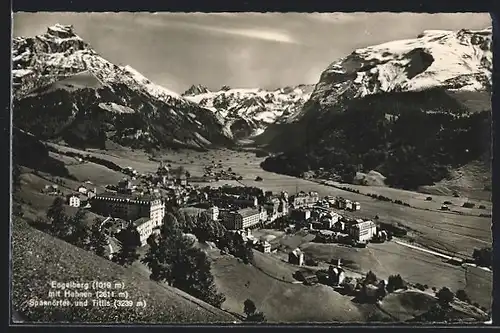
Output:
[253, 229, 493, 308]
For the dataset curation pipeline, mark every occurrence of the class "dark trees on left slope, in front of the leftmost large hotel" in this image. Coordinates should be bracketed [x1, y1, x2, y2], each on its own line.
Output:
[34, 197, 108, 257]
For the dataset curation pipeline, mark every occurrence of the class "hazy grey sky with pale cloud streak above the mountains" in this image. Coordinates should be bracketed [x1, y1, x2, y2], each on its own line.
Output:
[13, 12, 491, 93]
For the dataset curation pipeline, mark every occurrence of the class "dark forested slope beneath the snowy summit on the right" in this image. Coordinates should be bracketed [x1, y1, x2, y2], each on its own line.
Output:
[262, 91, 491, 189]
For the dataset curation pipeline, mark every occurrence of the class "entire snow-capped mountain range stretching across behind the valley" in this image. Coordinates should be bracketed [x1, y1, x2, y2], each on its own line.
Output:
[12, 24, 492, 189]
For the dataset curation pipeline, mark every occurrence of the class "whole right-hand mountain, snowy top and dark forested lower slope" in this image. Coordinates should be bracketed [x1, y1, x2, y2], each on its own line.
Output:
[261, 29, 492, 188]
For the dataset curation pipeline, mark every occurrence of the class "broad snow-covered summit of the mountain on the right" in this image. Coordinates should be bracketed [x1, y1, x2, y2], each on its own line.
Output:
[311, 28, 492, 109]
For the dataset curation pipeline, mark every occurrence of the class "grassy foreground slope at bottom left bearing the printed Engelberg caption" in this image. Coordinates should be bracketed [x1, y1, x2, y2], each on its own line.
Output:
[12, 220, 236, 323]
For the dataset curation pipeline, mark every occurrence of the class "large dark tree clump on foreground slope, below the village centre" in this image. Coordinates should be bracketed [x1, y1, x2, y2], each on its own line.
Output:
[141, 213, 225, 308]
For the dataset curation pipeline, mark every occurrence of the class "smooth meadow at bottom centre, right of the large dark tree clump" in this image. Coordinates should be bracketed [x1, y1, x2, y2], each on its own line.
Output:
[205, 248, 364, 322]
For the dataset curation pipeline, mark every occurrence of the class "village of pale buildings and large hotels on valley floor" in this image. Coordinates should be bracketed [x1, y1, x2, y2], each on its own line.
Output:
[53, 163, 410, 283]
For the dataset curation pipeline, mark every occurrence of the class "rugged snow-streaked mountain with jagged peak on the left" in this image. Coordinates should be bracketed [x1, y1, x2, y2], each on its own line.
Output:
[13, 24, 231, 148]
